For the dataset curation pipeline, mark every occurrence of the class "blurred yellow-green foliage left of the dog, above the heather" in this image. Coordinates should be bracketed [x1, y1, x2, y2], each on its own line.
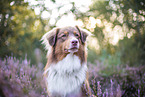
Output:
[0, 0, 47, 64]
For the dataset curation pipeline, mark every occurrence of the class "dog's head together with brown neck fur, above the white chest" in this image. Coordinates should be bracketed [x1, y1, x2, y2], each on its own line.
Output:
[42, 26, 90, 62]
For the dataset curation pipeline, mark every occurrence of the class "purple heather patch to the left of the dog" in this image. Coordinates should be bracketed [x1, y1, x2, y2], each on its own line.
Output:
[0, 57, 47, 97]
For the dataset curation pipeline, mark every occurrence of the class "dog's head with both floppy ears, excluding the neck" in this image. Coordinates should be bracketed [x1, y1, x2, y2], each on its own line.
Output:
[42, 26, 90, 53]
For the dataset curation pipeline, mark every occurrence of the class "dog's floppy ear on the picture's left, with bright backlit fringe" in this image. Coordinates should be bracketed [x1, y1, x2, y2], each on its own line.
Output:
[41, 28, 59, 49]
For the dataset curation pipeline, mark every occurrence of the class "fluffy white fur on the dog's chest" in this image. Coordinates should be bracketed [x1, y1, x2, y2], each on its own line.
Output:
[46, 54, 87, 96]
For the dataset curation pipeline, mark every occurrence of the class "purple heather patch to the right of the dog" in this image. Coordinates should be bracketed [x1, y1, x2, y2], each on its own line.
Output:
[88, 61, 145, 97]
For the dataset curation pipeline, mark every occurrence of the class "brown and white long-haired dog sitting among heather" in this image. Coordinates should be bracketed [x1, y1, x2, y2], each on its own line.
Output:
[42, 26, 91, 97]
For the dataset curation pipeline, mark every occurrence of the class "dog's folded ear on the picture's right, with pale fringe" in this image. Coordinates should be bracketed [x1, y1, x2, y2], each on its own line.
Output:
[76, 26, 91, 44]
